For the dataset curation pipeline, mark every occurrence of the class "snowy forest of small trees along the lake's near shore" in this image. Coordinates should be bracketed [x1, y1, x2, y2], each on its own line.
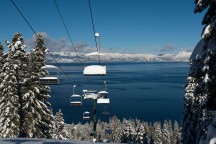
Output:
[65, 116, 181, 144]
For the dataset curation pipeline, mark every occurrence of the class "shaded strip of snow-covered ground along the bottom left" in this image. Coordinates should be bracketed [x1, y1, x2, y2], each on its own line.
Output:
[0, 138, 93, 144]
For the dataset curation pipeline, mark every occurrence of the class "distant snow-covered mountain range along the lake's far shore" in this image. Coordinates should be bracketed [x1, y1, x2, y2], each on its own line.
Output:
[47, 51, 191, 63]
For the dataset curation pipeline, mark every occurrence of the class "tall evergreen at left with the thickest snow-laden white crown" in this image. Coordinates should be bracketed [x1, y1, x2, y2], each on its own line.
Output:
[1, 33, 27, 136]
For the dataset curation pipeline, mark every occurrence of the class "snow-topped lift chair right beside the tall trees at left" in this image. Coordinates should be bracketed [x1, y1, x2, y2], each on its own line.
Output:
[40, 65, 59, 85]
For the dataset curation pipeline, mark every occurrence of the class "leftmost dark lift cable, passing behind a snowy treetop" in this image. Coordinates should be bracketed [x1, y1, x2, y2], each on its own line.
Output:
[11, 0, 69, 79]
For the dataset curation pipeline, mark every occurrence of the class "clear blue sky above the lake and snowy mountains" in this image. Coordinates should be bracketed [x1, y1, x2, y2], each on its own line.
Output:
[0, 0, 203, 53]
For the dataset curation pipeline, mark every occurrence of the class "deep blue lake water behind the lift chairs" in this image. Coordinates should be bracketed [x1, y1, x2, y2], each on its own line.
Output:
[49, 62, 189, 123]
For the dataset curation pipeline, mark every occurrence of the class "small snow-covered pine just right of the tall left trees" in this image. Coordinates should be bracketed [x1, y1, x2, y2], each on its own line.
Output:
[55, 109, 68, 140]
